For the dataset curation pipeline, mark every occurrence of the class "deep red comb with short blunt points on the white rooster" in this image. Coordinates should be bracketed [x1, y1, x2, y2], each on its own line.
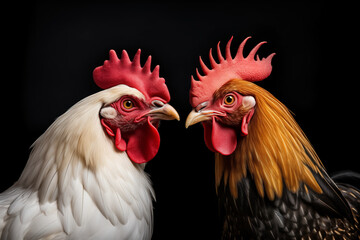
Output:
[93, 49, 170, 102]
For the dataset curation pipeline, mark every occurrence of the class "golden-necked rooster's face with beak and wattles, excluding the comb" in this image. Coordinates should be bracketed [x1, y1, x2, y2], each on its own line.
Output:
[186, 80, 256, 155]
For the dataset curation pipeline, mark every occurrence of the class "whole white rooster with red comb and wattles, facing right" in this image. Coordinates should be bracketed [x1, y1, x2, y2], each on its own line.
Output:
[0, 50, 179, 239]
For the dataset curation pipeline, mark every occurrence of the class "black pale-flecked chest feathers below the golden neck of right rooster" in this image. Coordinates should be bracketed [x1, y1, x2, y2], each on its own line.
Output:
[217, 173, 360, 240]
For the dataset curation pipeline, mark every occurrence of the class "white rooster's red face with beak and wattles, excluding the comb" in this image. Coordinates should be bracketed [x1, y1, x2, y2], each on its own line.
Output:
[100, 89, 179, 163]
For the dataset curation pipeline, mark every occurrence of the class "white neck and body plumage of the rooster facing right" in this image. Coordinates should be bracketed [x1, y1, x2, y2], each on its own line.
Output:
[0, 85, 154, 239]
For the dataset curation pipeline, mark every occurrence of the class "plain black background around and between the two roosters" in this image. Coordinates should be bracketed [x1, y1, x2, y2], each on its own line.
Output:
[0, 1, 360, 239]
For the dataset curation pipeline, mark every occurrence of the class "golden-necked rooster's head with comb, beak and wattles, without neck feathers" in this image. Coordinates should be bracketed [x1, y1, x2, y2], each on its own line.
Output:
[186, 37, 275, 155]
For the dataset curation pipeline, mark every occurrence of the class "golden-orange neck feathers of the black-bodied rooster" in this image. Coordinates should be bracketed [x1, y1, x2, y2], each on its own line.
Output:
[215, 79, 322, 200]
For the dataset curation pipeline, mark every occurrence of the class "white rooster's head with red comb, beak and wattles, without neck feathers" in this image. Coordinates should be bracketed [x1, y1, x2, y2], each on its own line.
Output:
[93, 49, 179, 164]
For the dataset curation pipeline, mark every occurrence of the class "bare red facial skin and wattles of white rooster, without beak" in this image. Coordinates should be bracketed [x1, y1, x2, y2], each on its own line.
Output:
[101, 96, 160, 163]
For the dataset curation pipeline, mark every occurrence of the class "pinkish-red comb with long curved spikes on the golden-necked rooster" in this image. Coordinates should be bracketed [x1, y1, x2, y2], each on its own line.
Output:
[190, 37, 275, 107]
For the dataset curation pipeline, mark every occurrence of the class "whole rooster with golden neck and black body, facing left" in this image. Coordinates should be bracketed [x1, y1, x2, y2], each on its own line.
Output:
[186, 38, 360, 240]
